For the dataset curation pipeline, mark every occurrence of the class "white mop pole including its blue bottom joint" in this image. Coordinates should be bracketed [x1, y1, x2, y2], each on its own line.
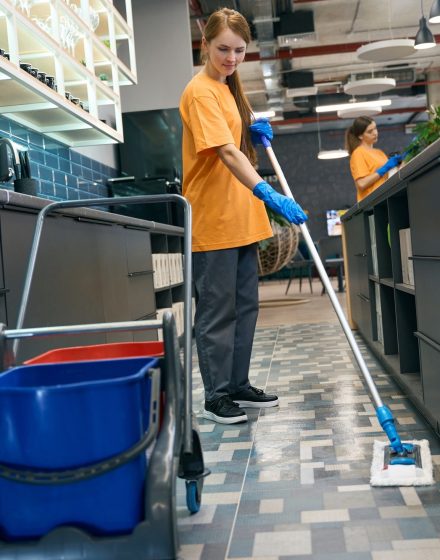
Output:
[261, 136, 409, 454]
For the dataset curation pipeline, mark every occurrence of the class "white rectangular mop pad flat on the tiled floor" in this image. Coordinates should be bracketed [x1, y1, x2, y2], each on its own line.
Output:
[370, 439, 434, 486]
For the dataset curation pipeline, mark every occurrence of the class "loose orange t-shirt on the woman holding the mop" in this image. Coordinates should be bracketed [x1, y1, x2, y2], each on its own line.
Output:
[179, 73, 273, 252]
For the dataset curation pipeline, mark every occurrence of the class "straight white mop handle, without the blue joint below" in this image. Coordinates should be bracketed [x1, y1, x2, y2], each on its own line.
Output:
[261, 136, 383, 408]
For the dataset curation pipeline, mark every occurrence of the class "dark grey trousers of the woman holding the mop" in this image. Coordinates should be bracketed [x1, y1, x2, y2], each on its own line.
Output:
[193, 243, 258, 401]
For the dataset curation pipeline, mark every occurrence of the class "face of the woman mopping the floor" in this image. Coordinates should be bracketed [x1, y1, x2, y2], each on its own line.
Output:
[203, 28, 246, 82]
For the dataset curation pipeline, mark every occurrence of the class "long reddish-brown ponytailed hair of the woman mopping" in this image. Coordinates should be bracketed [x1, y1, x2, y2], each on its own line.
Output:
[201, 8, 257, 165]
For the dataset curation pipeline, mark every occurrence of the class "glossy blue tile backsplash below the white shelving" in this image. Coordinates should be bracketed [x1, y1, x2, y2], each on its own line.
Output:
[0, 116, 119, 200]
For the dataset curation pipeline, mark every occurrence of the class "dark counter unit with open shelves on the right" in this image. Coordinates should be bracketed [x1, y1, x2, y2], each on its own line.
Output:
[342, 151, 440, 433]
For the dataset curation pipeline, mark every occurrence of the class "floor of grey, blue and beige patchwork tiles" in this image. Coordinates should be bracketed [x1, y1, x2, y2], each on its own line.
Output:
[178, 285, 440, 560]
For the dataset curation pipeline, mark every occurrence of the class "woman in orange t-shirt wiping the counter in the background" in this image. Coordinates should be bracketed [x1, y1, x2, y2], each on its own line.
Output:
[345, 117, 402, 202]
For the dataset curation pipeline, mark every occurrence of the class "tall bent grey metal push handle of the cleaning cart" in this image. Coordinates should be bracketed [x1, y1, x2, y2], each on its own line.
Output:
[13, 194, 193, 453]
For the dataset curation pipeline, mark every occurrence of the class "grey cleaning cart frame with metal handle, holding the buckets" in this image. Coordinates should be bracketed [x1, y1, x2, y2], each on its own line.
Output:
[0, 194, 205, 560]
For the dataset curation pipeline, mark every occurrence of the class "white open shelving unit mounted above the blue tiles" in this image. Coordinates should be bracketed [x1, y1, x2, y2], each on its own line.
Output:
[0, 0, 137, 146]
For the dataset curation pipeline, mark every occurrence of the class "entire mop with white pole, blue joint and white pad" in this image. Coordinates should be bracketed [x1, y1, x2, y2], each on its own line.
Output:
[261, 135, 434, 486]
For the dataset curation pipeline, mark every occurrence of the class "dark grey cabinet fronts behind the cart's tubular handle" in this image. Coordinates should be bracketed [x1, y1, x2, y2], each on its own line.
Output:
[0, 201, 162, 361]
